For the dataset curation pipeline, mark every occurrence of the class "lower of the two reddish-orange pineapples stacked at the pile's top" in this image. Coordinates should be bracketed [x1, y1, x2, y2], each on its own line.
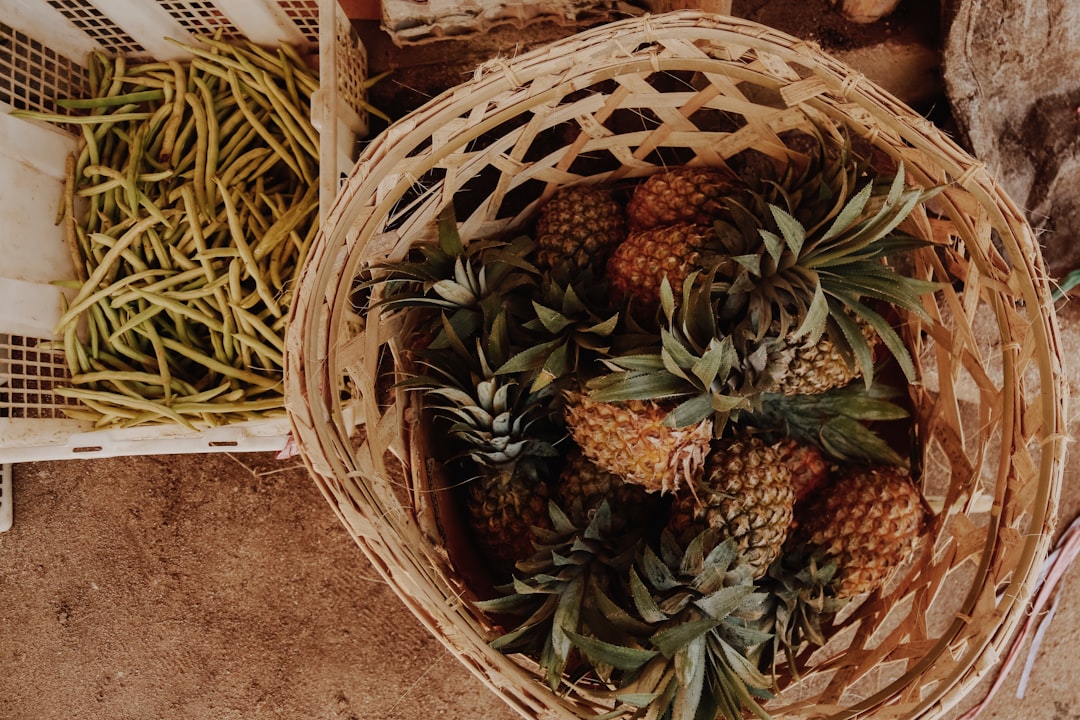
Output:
[607, 223, 712, 312]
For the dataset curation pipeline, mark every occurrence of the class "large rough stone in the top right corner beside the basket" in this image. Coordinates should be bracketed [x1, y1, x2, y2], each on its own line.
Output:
[944, 0, 1080, 277]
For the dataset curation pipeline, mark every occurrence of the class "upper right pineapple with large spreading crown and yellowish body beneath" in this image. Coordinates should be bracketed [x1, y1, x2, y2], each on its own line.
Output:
[715, 144, 936, 394]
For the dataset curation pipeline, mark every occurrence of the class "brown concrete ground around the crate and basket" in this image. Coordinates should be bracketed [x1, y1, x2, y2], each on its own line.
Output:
[0, 0, 1080, 720]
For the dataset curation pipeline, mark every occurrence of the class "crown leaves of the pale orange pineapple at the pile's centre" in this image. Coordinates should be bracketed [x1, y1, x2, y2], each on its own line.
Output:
[590, 272, 783, 434]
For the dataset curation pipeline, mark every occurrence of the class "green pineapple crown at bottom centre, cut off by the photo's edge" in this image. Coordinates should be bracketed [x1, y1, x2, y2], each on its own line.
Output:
[571, 533, 771, 720]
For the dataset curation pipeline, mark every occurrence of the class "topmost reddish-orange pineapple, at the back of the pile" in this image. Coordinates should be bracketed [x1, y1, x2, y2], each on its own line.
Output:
[626, 166, 741, 231]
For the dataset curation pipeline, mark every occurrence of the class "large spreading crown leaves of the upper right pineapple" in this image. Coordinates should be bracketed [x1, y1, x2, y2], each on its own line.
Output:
[714, 164, 940, 385]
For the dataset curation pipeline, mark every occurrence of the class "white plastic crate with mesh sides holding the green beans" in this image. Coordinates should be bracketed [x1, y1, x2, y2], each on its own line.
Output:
[0, 0, 367, 463]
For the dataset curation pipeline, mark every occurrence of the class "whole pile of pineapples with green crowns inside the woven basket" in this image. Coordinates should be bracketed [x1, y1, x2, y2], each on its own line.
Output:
[367, 127, 935, 720]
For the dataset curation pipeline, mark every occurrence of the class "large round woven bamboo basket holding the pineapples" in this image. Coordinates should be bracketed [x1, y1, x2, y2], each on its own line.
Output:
[286, 11, 1066, 719]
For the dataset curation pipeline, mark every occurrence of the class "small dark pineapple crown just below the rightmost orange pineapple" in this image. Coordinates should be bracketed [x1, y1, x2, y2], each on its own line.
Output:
[759, 549, 848, 679]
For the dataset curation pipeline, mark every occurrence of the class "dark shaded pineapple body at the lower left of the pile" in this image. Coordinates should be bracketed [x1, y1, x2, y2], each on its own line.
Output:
[465, 472, 552, 572]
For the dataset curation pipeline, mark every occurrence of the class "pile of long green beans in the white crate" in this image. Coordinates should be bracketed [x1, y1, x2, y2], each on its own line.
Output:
[11, 39, 319, 429]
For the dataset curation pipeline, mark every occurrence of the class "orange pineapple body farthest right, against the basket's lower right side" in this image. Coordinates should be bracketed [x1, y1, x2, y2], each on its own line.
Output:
[796, 465, 930, 598]
